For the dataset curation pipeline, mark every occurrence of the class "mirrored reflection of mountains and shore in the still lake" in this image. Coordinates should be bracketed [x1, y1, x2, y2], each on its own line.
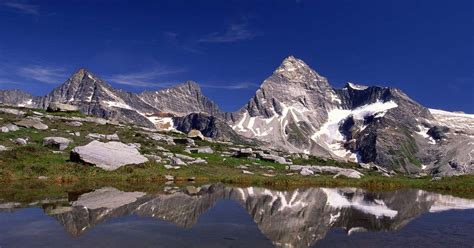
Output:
[0, 184, 474, 247]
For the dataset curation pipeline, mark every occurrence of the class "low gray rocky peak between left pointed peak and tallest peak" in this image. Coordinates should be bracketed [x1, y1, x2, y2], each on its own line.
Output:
[139, 81, 224, 117]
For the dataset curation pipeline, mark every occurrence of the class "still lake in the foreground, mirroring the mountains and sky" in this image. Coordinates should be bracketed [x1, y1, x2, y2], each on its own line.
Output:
[0, 184, 474, 248]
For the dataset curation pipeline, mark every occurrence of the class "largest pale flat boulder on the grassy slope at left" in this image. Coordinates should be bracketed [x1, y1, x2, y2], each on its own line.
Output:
[71, 140, 148, 171]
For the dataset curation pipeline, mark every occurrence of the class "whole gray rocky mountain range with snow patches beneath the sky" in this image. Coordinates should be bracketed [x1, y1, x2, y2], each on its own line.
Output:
[0, 56, 474, 176]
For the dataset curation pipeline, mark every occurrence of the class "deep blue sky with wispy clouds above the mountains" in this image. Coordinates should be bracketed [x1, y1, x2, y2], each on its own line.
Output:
[0, 0, 474, 113]
